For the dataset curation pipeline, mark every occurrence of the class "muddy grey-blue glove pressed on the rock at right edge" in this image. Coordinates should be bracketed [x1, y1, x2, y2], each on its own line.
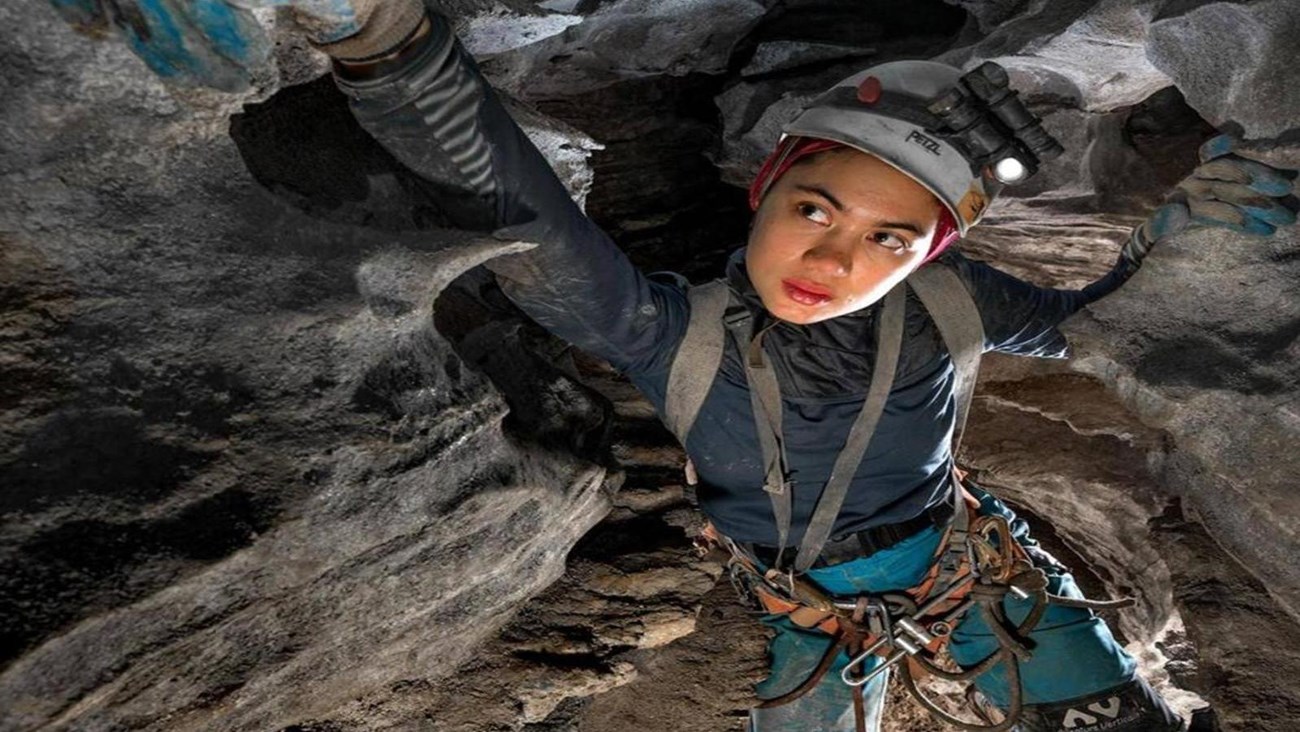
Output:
[1121, 135, 1300, 272]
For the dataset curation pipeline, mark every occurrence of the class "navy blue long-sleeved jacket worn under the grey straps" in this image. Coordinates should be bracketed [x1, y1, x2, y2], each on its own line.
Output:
[339, 15, 1128, 545]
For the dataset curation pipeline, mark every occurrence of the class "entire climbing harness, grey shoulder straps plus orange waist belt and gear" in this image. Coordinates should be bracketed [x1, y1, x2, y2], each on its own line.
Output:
[664, 264, 1132, 732]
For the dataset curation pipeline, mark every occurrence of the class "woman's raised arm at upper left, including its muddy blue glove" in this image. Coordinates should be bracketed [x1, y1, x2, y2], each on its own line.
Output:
[52, 0, 686, 371]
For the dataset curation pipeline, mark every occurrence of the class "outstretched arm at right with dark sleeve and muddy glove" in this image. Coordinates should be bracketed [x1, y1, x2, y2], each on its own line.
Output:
[943, 135, 1300, 358]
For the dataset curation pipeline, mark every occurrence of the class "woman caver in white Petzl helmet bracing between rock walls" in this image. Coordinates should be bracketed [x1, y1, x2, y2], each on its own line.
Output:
[56, 0, 1295, 732]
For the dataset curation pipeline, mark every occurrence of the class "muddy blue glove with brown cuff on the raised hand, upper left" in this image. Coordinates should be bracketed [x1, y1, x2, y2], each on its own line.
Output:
[51, 0, 424, 91]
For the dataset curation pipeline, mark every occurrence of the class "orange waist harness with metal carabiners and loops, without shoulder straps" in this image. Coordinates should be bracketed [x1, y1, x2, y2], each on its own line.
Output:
[701, 477, 1132, 732]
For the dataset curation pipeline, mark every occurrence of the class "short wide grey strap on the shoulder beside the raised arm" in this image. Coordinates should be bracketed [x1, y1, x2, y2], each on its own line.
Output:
[663, 280, 731, 447]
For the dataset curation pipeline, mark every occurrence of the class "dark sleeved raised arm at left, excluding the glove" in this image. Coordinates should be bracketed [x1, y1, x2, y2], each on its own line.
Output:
[335, 16, 686, 371]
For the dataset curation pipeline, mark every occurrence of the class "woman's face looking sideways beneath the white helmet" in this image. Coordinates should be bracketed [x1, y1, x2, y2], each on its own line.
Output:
[745, 148, 940, 324]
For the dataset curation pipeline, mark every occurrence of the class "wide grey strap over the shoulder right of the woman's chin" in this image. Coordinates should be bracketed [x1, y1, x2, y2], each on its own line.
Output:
[907, 263, 984, 458]
